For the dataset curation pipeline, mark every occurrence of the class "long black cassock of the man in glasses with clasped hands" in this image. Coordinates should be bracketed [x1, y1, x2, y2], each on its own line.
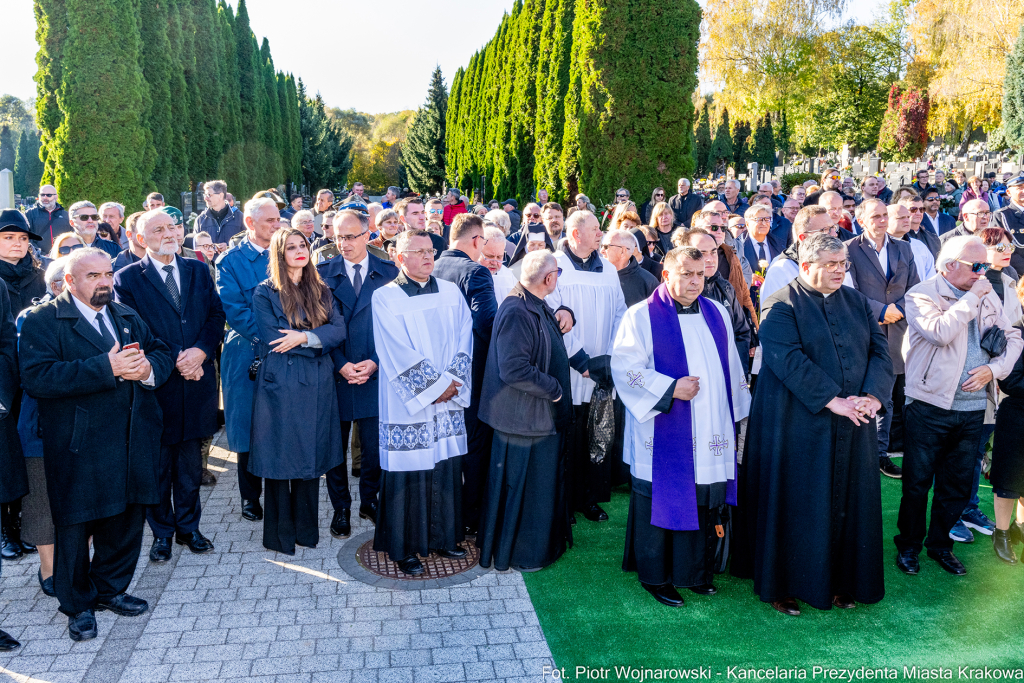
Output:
[732, 278, 894, 609]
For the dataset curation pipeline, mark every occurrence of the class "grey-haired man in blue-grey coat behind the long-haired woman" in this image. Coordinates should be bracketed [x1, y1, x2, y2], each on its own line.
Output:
[217, 197, 281, 521]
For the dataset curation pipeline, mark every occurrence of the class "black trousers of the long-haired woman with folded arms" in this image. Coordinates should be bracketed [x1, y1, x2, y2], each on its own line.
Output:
[263, 478, 319, 555]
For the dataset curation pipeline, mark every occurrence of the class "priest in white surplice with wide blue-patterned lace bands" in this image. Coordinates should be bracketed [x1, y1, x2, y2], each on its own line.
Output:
[373, 230, 473, 575]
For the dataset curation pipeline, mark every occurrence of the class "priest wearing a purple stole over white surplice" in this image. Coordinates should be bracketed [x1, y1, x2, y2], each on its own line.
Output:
[611, 247, 751, 607]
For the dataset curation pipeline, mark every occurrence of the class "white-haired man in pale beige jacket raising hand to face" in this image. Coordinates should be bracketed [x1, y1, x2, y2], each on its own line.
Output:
[895, 235, 1024, 575]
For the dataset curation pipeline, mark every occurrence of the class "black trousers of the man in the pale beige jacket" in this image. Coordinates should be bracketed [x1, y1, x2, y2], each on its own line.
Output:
[894, 400, 985, 552]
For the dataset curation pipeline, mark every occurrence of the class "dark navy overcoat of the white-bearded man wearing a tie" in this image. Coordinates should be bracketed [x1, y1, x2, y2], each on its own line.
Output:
[114, 256, 224, 445]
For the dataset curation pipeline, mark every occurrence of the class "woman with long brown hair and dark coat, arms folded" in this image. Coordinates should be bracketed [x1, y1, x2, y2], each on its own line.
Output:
[249, 228, 345, 555]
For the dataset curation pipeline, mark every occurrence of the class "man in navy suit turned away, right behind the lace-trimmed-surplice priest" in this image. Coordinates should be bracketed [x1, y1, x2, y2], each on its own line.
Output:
[433, 213, 498, 533]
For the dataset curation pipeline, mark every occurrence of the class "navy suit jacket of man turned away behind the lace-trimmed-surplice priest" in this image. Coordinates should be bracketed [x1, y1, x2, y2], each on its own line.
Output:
[433, 249, 498, 414]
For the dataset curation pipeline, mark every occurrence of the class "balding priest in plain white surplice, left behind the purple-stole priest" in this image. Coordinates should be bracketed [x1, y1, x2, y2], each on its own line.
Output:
[546, 211, 626, 521]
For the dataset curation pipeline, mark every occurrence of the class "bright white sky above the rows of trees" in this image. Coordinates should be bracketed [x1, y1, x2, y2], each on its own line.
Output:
[0, 0, 883, 114]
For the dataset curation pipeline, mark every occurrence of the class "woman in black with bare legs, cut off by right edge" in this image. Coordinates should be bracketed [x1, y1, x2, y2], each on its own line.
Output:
[989, 299, 1024, 564]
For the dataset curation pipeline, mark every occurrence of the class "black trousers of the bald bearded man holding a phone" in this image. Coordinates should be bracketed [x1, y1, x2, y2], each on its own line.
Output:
[53, 505, 145, 616]
